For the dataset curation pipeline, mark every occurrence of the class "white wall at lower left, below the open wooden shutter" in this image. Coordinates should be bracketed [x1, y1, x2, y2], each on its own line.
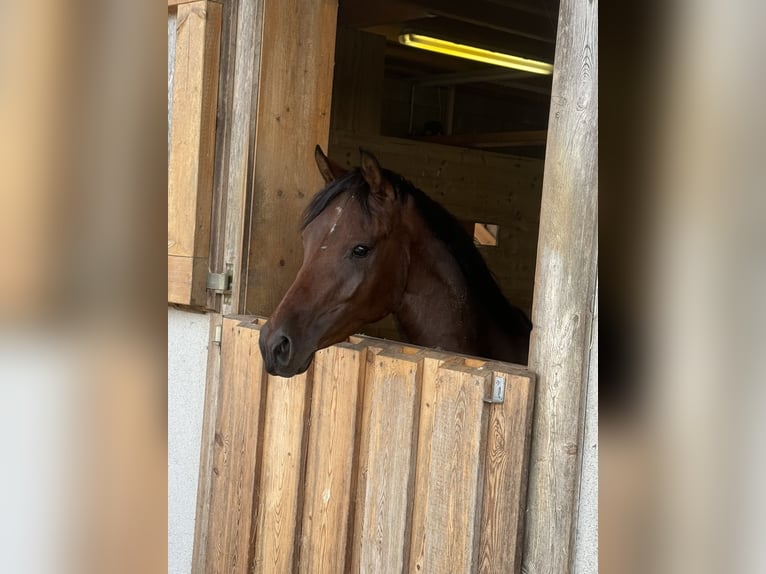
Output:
[168, 308, 210, 574]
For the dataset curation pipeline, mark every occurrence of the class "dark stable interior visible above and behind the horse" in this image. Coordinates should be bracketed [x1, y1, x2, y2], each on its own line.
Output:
[328, 0, 559, 340]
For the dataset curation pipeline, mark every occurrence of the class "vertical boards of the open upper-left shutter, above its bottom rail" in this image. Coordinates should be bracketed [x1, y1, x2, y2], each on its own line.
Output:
[168, 0, 221, 304]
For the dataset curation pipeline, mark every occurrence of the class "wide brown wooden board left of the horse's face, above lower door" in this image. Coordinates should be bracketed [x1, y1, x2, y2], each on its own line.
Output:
[246, 0, 337, 315]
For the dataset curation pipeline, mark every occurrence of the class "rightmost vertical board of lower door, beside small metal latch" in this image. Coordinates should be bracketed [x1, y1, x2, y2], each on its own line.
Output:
[479, 372, 534, 574]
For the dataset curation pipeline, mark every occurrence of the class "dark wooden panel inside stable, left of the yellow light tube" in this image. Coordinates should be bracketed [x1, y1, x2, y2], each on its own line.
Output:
[331, 26, 386, 134]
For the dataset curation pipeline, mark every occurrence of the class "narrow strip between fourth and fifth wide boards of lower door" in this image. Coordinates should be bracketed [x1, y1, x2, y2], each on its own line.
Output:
[409, 354, 444, 572]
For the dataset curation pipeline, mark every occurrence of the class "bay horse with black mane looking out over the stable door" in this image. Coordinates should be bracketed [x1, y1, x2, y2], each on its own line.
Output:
[260, 145, 532, 377]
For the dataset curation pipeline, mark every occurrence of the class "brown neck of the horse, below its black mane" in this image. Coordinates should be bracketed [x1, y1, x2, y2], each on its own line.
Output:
[394, 223, 482, 354]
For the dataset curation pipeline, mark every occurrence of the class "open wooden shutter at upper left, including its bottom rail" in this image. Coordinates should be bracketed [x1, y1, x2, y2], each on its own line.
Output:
[168, 0, 221, 307]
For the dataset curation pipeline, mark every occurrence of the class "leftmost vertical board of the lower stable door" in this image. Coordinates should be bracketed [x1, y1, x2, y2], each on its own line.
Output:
[205, 318, 264, 573]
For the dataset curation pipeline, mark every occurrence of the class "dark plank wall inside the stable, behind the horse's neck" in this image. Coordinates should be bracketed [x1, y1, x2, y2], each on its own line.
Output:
[329, 131, 543, 338]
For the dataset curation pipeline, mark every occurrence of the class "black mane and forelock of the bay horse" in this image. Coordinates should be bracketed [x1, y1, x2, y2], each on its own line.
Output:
[302, 168, 532, 335]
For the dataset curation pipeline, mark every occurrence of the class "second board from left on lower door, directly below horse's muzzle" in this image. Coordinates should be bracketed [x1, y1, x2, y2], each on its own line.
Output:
[251, 369, 311, 573]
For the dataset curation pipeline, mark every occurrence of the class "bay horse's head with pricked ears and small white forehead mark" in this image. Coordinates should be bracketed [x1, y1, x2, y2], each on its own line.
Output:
[260, 146, 409, 377]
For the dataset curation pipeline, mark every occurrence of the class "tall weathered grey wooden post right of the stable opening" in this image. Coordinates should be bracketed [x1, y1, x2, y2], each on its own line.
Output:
[523, 0, 598, 574]
